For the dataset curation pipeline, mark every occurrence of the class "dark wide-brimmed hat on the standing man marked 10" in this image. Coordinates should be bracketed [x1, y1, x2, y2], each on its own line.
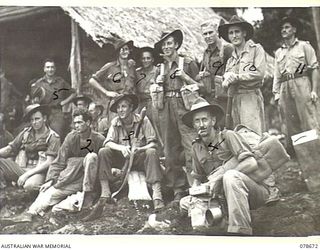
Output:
[218, 15, 253, 42]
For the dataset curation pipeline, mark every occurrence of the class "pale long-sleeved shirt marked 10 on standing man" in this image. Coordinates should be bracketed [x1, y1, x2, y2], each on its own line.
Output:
[226, 40, 266, 89]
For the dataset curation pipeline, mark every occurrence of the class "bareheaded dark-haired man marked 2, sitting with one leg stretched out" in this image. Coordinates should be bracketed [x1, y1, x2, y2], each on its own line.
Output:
[1, 109, 105, 223]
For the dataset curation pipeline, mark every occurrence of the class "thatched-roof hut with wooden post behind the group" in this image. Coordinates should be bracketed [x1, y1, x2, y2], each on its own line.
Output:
[0, 6, 221, 125]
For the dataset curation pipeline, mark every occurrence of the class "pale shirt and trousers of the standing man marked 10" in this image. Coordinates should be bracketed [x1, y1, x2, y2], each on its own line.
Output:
[226, 40, 266, 135]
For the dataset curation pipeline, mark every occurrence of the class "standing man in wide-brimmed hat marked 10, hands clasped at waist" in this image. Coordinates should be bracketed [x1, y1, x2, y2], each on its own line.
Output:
[218, 16, 266, 135]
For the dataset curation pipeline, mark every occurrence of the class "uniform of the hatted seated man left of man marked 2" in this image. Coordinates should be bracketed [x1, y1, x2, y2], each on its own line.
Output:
[0, 127, 61, 190]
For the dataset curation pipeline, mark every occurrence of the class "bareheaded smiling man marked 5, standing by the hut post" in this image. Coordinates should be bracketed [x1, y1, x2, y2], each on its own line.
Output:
[30, 59, 76, 140]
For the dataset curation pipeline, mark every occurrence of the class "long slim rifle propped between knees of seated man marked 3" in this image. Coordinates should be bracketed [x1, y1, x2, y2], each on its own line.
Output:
[111, 107, 147, 198]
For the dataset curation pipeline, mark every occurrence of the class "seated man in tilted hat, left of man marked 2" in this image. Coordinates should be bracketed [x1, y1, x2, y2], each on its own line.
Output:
[0, 104, 60, 190]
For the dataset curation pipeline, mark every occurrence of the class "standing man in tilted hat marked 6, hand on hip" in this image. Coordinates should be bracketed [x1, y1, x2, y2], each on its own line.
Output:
[89, 40, 136, 128]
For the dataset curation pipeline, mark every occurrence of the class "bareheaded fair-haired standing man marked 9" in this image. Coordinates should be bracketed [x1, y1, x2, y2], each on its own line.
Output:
[197, 20, 233, 124]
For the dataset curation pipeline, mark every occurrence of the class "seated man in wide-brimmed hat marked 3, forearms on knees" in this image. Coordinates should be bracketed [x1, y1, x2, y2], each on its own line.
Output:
[84, 94, 164, 220]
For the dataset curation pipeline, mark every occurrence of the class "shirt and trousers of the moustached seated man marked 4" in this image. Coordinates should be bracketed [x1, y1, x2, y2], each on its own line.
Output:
[180, 130, 269, 235]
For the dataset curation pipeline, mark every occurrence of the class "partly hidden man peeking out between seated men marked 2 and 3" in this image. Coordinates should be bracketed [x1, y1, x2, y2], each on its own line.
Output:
[88, 102, 109, 136]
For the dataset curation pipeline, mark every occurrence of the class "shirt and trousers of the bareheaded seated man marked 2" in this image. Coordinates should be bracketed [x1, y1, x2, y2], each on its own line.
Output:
[28, 131, 105, 214]
